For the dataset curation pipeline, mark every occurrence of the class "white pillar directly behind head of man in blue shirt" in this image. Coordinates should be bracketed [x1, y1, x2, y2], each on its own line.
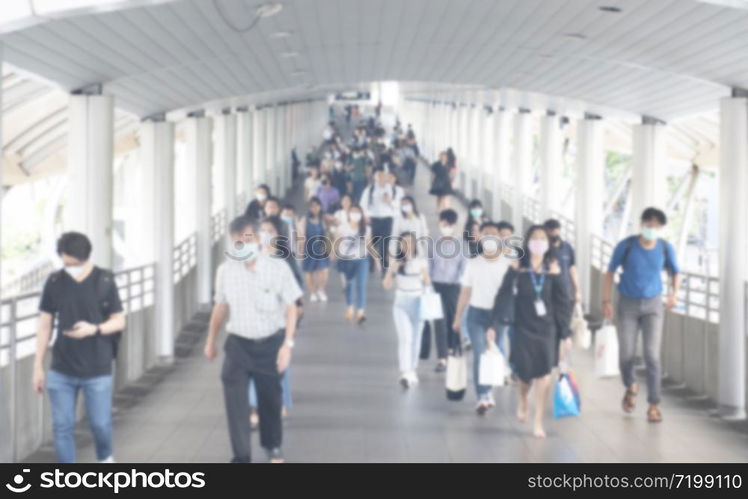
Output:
[629, 123, 667, 230]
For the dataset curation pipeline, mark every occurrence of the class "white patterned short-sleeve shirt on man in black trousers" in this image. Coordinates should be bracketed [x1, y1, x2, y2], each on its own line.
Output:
[215, 255, 302, 340]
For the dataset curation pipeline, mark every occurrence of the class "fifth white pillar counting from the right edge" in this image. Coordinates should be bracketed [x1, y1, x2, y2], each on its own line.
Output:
[511, 109, 532, 233]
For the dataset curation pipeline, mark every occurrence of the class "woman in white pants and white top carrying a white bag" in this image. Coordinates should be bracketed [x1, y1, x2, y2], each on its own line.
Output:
[383, 232, 431, 388]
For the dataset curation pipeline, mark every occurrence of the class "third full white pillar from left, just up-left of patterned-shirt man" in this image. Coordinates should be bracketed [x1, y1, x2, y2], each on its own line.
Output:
[185, 117, 213, 307]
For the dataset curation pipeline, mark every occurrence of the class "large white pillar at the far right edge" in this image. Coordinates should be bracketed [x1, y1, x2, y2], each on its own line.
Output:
[717, 97, 748, 419]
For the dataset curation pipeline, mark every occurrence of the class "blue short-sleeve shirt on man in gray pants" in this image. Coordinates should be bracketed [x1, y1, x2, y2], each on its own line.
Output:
[608, 237, 680, 298]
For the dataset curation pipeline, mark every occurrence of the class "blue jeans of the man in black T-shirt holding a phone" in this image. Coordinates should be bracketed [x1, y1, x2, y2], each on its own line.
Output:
[47, 371, 112, 463]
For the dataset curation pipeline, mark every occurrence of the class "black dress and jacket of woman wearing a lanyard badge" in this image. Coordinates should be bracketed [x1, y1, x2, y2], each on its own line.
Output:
[493, 268, 572, 383]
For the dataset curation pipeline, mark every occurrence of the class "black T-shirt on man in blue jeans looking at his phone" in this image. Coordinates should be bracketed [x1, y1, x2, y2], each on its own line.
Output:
[39, 267, 122, 378]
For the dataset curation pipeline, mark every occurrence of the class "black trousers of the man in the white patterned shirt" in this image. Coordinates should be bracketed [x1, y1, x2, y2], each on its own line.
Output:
[221, 330, 285, 463]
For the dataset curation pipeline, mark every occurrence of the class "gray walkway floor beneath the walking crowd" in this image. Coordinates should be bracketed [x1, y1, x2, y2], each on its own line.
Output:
[30, 153, 748, 462]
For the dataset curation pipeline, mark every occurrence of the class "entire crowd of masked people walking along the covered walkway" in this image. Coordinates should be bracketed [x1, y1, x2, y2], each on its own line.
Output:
[34, 109, 679, 462]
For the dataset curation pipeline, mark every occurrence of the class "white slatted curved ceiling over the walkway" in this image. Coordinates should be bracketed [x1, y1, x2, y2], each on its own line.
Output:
[0, 0, 748, 121]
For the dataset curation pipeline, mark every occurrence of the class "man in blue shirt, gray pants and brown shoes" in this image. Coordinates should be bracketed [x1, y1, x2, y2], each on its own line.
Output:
[603, 208, 680, 423]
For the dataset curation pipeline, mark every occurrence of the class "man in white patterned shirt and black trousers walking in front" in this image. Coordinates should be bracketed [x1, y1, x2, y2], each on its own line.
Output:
[205, 217, 301, 463]
